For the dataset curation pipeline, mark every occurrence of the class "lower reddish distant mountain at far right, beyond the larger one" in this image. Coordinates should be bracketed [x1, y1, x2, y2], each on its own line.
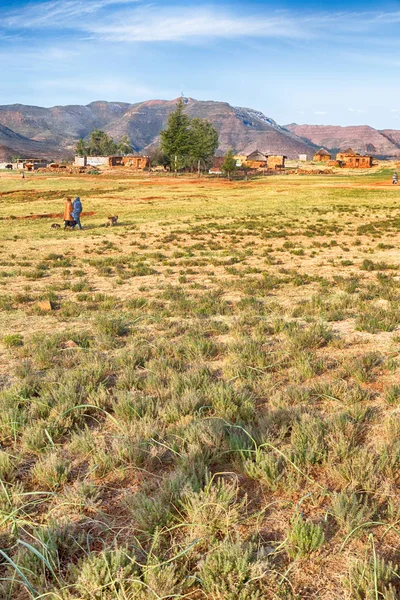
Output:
[285, 123, 400, 158]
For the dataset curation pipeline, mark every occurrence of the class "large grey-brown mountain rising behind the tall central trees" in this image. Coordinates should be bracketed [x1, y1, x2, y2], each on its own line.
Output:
[0, 98, 314, 158]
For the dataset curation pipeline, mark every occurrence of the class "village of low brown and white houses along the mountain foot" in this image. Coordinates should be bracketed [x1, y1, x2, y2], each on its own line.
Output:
[0, 148, 374, 176]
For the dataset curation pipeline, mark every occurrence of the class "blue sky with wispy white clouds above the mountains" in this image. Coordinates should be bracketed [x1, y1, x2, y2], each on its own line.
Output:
[0, 0, 400, 129]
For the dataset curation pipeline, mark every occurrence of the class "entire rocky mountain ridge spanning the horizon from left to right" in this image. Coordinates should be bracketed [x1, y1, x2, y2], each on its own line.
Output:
[0, 98, 400, 160]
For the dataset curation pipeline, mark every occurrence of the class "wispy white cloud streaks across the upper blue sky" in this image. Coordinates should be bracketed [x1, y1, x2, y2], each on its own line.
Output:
[0, 0, 400, 42]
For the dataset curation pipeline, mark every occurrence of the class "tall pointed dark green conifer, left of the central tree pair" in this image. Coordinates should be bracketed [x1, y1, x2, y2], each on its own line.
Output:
[160, 98, 190, 175]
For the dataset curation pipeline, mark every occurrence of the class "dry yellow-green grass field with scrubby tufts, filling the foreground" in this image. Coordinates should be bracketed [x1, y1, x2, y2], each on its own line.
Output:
[0, 170, 400, 600]
